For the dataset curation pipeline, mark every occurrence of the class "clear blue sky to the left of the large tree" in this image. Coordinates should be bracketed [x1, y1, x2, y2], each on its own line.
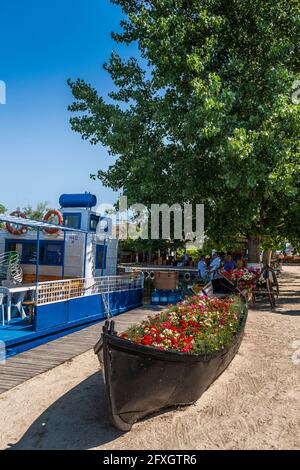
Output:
[0, 0, 137, 210]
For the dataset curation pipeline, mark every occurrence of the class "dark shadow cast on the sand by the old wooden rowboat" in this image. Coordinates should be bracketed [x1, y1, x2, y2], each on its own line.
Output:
[9, 372, 122, 450]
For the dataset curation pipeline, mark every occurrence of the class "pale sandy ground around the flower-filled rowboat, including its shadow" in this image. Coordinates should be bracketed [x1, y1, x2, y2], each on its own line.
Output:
[0, 267, 300, 450]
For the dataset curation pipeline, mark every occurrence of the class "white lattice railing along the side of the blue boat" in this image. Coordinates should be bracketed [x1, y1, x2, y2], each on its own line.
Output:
[36, 273, 144, 305]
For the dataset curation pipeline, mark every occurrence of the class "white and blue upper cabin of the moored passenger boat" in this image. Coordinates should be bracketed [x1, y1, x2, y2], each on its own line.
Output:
[0, 193, 118, 283]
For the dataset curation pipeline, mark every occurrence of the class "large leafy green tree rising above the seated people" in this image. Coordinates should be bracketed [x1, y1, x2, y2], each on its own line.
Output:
[69, 0, 300, 261]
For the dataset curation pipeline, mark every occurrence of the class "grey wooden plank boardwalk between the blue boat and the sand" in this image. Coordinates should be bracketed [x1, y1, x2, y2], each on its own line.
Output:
[0, 305, 160, 394]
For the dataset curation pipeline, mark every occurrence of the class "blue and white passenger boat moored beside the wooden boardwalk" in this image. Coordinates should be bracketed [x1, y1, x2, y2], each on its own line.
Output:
[0, 193, 143, 356]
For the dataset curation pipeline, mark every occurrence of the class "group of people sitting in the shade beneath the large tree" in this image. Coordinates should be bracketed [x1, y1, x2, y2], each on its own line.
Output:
[198, 252, 244, 281]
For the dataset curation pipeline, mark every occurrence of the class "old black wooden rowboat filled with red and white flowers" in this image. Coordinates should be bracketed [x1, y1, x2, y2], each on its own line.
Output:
[95, 280, 247, 431]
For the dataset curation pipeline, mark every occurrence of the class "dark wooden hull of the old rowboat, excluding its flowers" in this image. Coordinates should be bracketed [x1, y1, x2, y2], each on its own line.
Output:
[94, 277, 247, 431]
